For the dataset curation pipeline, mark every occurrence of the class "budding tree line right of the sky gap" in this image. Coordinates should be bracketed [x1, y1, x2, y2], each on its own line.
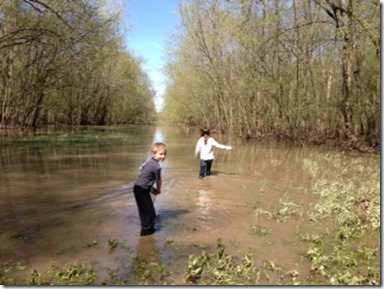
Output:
[164, 0, 380, 147]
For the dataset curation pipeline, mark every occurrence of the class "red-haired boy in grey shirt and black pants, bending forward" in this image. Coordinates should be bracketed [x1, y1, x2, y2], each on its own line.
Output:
[133, 142, 168, 236]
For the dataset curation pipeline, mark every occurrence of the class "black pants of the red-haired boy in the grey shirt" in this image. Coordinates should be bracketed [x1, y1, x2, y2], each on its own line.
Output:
[133, 186, 156, 236]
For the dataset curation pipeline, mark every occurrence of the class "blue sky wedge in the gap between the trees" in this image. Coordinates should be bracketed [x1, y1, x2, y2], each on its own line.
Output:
[125, 0, 179, 111]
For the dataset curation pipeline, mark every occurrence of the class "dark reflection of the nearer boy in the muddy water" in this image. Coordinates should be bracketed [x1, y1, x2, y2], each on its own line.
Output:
[132, 235, 162, 285]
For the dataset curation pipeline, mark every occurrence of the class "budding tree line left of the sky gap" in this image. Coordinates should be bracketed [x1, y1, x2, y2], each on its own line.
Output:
[0, 0, 156, 128]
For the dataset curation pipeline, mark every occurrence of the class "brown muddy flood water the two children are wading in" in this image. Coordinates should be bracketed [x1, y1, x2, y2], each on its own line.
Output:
[0, 126, 378, 284]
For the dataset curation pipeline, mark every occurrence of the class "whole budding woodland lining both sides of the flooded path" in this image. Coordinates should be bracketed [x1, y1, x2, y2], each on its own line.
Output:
[0, 0, 380, 151]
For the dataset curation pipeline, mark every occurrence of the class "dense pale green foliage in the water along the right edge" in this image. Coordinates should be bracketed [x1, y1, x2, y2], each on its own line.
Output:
[301, 155, 380, 285]
